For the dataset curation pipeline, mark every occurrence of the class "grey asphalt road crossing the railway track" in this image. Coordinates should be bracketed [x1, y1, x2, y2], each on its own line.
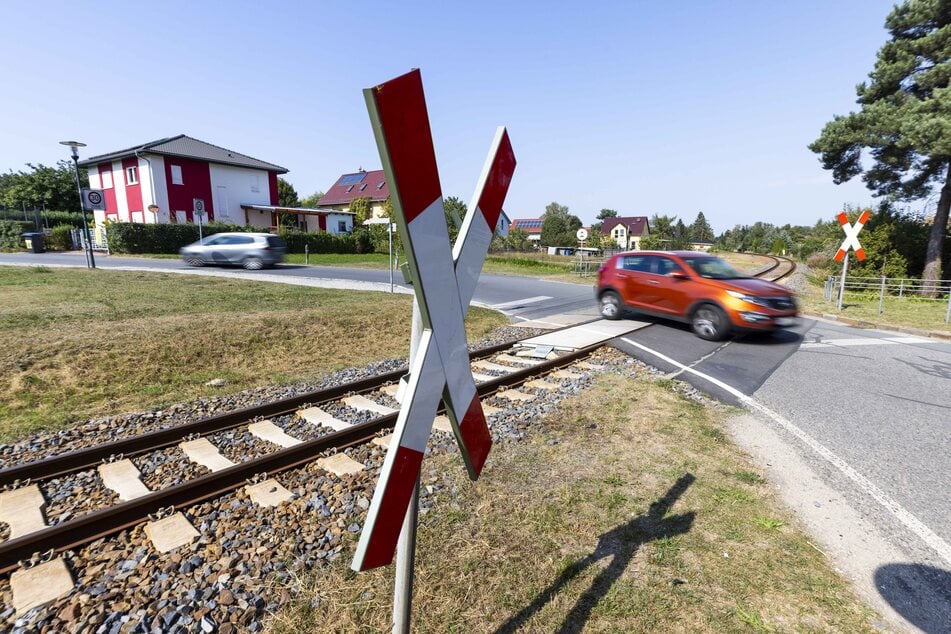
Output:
[0, 253, 951, 632]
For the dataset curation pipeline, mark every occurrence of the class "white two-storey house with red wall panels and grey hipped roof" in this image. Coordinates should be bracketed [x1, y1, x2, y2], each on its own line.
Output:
[79, 134, 287, 227]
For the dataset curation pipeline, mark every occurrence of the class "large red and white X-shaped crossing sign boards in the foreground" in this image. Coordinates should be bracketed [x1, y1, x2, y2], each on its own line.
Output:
[351, 70, 515, 571]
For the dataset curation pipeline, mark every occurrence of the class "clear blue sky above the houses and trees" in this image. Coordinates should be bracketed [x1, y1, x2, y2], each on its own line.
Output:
[0, 0, 921, 233]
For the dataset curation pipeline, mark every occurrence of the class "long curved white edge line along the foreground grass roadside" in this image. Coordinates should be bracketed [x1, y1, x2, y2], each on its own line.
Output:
[621, 337, 951, 564]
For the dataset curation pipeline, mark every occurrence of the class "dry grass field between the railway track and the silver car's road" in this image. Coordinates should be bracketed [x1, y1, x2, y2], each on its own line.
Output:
[0, 267, 505, 440]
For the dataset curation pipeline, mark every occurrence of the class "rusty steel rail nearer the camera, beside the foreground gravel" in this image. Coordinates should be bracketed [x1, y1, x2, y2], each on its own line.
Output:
[0, 343, 601, 574]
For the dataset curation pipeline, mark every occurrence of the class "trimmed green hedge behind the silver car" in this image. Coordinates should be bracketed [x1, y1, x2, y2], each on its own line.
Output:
[104, 222, 373, 253]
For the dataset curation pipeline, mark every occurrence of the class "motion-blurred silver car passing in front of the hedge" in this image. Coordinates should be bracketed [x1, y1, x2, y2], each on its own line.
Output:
[179, 233, 287, 271]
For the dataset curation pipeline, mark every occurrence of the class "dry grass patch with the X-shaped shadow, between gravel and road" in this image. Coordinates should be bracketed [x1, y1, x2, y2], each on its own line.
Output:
[271, 375, 873, 632]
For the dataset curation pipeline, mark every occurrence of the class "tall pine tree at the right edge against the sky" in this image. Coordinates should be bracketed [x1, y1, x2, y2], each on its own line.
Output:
[809, 0, 951, 281]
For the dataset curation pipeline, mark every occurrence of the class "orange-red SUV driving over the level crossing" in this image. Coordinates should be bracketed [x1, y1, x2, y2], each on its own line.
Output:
[596, 251, 799, 341]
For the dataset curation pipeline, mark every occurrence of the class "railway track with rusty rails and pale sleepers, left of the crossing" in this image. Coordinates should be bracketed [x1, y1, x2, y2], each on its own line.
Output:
[0, 334, 600, 584]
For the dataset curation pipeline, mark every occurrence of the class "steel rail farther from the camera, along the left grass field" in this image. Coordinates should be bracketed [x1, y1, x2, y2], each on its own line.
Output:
[0, 340, 518, 487]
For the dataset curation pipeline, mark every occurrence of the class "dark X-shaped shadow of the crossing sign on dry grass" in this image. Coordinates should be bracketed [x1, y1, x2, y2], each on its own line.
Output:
[496, 473, 695, 634]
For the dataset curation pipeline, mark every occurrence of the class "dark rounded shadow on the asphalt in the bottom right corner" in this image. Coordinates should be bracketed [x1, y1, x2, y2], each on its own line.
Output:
[875, 563, 951, 634]
